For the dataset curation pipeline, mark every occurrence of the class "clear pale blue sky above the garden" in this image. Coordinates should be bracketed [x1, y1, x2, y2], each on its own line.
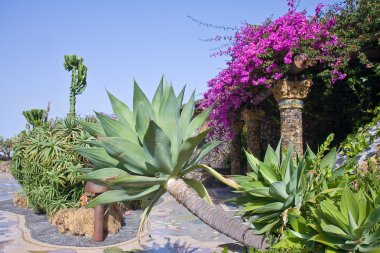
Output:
[0, 0, 337, 137]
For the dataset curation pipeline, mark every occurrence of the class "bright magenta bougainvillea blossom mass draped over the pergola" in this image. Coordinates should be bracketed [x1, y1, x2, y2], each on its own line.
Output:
[201, 0, 345, 136]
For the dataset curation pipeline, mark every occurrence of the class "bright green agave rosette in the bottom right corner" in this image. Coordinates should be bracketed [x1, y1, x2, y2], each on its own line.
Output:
[309, 187, 380, 253]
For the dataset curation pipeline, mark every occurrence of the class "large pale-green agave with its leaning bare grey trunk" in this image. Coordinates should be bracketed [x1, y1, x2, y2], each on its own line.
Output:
[77, 79, 265, 248]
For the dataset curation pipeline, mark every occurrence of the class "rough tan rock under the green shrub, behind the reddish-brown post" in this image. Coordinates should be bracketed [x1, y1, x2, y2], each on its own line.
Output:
[49, 205, 123, 237]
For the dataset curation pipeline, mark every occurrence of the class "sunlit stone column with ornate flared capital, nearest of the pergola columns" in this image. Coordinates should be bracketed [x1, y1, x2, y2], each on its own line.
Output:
[272, 79, 313, 155]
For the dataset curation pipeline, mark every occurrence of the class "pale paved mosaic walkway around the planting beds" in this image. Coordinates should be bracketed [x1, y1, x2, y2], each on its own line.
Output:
[0, 173, 243, 253]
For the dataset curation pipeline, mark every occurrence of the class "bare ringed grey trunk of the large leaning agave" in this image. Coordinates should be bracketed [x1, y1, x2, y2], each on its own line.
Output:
[166, 178, 267, 249]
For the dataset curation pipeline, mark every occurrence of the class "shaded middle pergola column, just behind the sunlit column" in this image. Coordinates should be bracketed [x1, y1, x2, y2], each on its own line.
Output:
[241, 108, 265, 159]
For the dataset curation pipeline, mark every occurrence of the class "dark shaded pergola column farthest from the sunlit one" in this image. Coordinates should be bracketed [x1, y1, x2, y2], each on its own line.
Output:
[230, 112, 244, 175]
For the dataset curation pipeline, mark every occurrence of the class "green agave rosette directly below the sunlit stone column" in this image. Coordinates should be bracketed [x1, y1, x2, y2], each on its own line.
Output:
[231, 144, 335, 234]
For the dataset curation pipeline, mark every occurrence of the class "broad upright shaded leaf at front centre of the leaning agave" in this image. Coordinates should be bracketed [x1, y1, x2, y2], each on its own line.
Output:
[143, 120, 173, 175]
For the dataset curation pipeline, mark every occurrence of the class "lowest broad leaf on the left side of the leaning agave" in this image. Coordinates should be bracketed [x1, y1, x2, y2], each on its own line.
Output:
[87, 185, 160, 208]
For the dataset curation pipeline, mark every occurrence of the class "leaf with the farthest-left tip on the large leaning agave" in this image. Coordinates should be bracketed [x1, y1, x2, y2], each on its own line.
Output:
[74, 147, 118, 168]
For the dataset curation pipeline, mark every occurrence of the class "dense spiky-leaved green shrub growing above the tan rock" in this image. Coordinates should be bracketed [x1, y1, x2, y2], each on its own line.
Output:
[11, 119, 90, 213]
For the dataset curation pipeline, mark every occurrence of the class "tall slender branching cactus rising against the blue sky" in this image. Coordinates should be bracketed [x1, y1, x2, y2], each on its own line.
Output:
[63, 54, 87, 118]
